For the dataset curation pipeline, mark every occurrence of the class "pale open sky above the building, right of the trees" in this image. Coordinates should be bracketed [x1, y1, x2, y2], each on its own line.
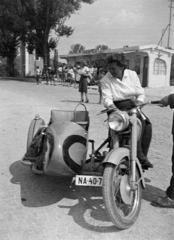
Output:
[55, 0, 174, 55]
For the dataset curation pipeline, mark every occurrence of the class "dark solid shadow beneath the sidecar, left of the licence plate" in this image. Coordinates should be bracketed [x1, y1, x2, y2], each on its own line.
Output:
[9, 161, 75, 207]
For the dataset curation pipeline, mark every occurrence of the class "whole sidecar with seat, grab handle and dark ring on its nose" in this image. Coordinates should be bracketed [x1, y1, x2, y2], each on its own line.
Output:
[21, 104, 90, 176]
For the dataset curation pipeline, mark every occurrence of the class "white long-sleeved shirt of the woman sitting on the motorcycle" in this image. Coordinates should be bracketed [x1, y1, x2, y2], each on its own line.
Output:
[101, 69, 145, 108]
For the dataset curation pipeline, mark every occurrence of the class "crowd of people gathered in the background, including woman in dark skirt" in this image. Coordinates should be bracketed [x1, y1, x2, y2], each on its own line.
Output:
[36, 61, 106, 104]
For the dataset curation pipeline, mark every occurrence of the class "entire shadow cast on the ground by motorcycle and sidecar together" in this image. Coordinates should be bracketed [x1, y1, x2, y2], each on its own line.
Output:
[10, 161, 164, 232]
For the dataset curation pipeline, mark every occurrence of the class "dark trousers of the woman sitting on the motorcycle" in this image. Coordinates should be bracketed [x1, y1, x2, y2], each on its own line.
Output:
[114, 100, 152, 160]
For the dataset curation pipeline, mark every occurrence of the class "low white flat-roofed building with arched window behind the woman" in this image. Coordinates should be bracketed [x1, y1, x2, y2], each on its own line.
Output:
[60, 44, 174, 88]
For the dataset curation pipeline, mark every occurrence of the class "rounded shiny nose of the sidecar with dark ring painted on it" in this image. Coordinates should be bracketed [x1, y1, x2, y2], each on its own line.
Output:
[44, 121, 88, 176]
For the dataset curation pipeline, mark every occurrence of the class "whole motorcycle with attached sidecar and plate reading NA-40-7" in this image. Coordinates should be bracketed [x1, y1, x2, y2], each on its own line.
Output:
[21, 101, 159, 229]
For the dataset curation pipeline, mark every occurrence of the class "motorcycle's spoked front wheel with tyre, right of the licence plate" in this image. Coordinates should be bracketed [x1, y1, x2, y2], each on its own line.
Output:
[102, 159, 142, 229]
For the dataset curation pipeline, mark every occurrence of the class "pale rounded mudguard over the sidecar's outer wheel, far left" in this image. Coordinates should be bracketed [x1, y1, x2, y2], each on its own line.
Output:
[27, 116, 45, 150]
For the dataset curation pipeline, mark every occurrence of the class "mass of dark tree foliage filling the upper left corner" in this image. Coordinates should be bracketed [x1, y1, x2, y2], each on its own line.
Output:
[0, 0, 95, 74]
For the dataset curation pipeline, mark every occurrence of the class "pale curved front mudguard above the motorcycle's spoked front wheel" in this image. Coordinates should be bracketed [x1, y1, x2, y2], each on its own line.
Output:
[103, 147, 146, 188]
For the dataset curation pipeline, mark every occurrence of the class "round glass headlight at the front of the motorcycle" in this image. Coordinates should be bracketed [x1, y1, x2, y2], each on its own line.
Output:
[108, 111, 129, 132]
